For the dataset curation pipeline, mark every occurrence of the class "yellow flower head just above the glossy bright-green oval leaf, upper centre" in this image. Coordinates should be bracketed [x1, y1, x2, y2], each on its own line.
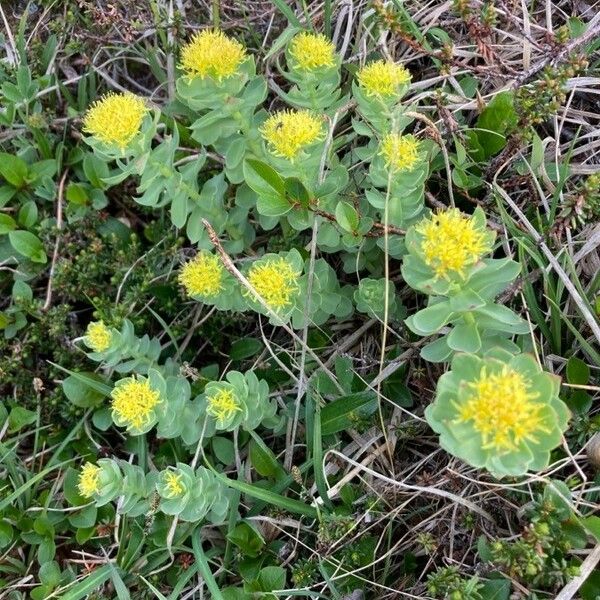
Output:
[260, 110, 323, 160]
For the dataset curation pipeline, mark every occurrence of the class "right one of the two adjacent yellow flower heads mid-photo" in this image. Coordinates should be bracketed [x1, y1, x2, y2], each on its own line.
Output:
[248, 257, 300, 311]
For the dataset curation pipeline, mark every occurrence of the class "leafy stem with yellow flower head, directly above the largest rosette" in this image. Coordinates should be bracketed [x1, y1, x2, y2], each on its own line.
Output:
[402, 208, 529, 362]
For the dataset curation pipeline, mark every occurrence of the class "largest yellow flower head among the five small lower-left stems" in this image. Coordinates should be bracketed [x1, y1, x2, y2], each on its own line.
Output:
[110, 377, 160, 429]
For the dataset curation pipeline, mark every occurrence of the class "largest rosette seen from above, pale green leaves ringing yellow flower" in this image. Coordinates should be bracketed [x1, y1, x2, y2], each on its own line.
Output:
[425, 349, 569, 477]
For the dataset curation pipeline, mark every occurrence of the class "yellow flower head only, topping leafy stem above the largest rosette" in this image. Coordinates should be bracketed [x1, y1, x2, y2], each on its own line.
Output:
[416, 208, 492, 277]
